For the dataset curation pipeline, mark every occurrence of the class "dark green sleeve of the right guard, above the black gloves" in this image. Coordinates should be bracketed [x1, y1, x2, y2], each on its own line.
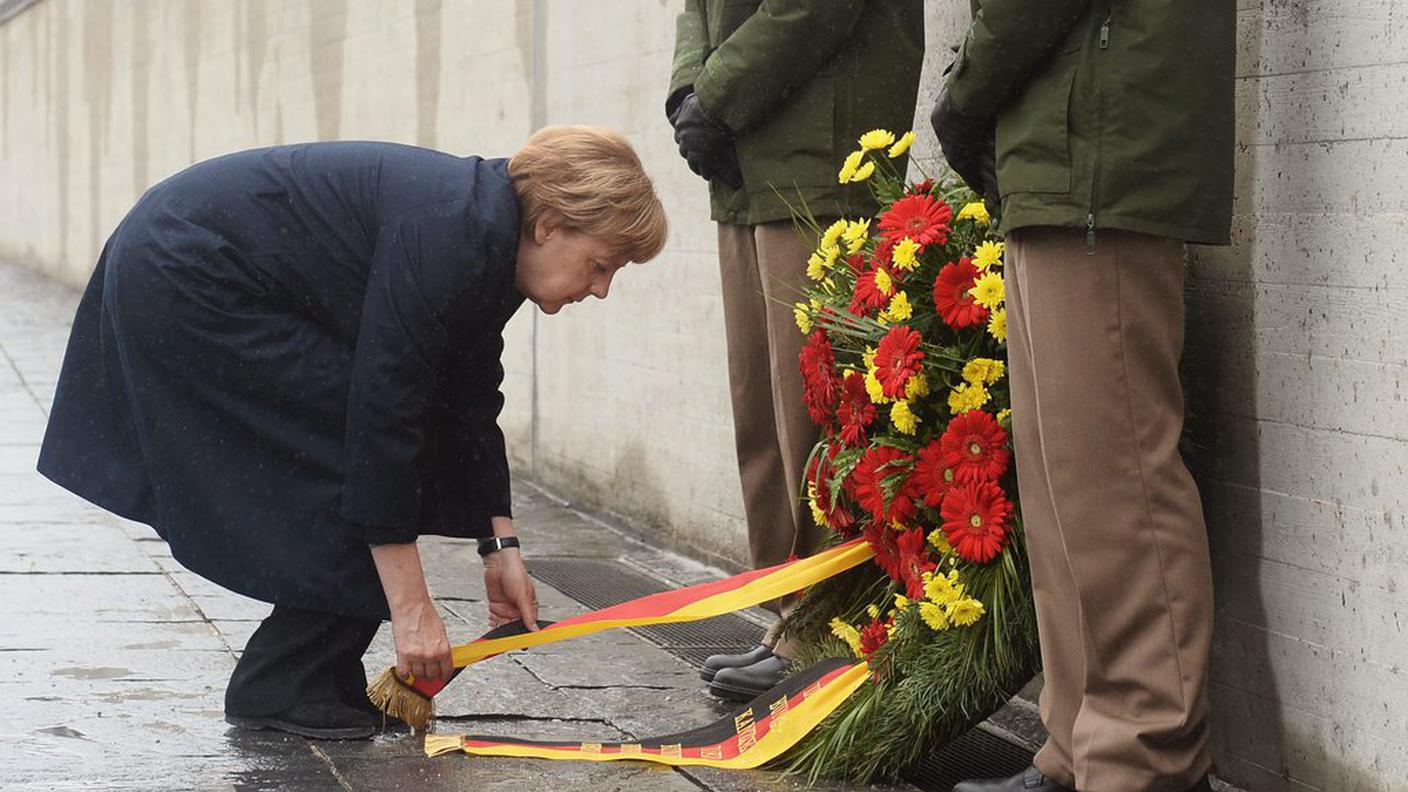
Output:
[948, 0, 1091, 118]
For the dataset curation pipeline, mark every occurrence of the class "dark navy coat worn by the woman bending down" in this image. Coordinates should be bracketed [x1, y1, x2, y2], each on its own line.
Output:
[39, 142, 522, 617]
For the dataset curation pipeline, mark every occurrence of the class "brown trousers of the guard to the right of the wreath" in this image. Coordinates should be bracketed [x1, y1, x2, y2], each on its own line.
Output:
[1007, 228, 1212, 792]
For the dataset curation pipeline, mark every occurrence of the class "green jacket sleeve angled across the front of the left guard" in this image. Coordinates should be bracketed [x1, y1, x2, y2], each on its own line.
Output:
[694, 0, 866, 132]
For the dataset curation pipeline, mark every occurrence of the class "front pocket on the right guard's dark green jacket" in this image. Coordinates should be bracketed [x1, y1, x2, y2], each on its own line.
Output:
[997, 54, 1080, 194]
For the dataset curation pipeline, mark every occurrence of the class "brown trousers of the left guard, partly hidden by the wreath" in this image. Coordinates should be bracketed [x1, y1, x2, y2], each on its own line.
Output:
[718, 223, 819, 657]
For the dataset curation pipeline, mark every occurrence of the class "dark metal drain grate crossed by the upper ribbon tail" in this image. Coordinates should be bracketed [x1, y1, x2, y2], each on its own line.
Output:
[529, 558, 763, 668]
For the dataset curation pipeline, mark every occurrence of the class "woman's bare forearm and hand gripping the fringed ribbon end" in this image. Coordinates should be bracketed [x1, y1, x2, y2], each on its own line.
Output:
[372, 541, 455, 679]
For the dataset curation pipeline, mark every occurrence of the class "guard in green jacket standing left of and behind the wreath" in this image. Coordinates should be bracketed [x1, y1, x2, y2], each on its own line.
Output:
[666, 0, 924, 700]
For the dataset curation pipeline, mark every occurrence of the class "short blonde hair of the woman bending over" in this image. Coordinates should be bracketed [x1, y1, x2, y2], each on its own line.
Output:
[508, 125, 669, 261]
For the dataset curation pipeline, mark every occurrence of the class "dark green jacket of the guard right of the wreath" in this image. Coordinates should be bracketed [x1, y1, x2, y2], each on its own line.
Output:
[948, 0, 1236, 244]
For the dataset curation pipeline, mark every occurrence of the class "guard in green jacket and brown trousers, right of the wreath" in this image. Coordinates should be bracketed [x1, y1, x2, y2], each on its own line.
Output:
[932, 0, 1236, 792]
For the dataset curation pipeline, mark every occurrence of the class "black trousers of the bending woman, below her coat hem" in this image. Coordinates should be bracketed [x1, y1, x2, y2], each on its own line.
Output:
[225, 605, 382, 717]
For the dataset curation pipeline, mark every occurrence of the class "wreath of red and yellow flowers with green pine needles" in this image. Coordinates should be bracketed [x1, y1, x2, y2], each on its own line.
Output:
[786, 130, 1038, 782]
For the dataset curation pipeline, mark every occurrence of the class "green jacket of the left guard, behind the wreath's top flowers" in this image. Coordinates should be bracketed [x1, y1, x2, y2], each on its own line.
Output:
[667, 0, 924, 224]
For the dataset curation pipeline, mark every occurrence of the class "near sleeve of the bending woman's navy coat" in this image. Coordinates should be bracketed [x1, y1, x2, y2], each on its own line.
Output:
[341, 207, 465, 543]
